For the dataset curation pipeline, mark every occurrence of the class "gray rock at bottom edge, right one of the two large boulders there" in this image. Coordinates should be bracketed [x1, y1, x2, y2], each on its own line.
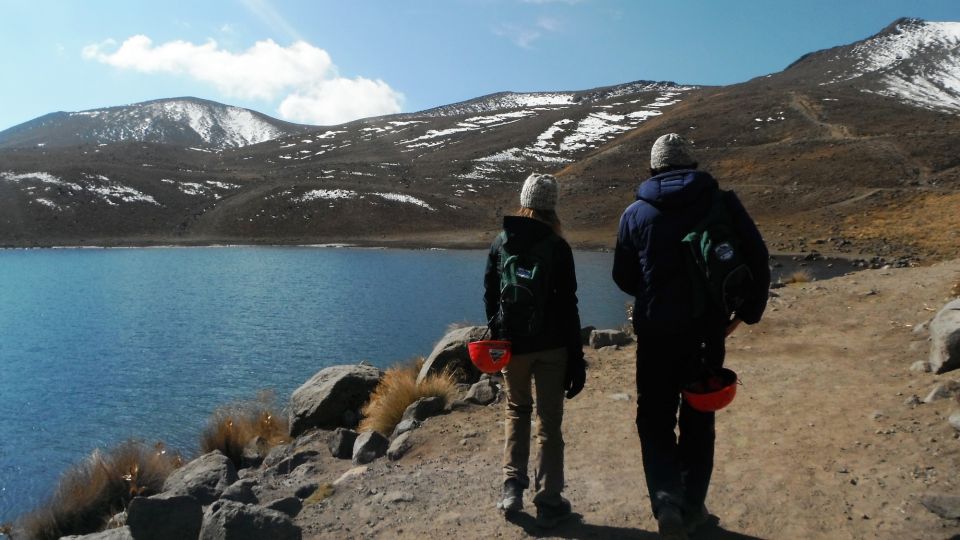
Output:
[200, 501, 303, 540]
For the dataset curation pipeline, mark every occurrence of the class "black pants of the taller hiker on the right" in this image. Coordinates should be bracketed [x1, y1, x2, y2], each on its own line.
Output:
[637, 325, 724, 516]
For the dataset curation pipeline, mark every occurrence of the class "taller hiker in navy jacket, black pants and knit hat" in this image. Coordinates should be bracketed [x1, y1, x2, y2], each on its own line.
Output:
[613, 133, 770, 538]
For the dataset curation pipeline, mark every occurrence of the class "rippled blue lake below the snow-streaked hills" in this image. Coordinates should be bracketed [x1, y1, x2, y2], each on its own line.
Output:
[0, 247, 629, 523]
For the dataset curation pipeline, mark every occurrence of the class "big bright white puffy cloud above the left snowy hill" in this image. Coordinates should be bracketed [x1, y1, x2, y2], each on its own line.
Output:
[83, 35, 403, 124]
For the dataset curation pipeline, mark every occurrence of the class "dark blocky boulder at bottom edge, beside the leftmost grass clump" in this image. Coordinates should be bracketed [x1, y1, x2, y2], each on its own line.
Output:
[127, 494, 203, 540]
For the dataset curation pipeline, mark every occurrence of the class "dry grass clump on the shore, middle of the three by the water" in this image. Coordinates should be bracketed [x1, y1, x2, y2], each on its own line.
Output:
[200, 392, 290, 469]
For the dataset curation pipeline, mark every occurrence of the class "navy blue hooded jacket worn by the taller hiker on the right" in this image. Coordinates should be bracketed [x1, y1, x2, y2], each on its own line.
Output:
[613, 170, 770, 330]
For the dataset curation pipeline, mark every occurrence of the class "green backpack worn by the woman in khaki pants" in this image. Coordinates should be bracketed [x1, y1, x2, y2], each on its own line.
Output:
[497, 233, 554, 339]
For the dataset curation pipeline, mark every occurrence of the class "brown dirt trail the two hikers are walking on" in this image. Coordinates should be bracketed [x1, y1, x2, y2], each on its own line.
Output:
[262, 260, 960, 539]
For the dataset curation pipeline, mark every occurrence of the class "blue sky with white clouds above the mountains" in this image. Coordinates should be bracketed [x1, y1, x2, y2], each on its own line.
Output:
[0, 0, 960, 130]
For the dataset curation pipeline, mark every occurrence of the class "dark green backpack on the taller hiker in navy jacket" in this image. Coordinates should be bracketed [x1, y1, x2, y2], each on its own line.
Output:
[682, 189, 753, 318]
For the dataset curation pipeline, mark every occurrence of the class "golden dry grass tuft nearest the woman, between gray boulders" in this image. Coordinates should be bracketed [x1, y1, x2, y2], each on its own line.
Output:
[360, 357, 457, 437]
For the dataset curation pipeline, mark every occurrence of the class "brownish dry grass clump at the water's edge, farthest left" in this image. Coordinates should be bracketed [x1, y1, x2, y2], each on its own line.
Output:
[17, 441, 182, 540]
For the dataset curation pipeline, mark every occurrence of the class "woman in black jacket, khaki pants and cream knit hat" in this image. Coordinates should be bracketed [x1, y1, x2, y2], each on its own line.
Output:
[484, 174, 586, 527]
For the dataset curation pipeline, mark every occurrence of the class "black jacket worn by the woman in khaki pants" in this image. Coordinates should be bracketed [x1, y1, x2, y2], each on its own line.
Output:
[483, 216, 583, 358]
